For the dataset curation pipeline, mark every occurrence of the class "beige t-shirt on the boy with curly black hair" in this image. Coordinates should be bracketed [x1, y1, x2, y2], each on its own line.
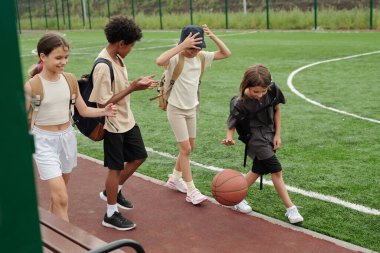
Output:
[89, 48, 136, 133]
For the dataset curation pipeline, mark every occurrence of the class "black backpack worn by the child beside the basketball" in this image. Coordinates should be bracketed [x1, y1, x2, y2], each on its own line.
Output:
[230, 83, 277, 189]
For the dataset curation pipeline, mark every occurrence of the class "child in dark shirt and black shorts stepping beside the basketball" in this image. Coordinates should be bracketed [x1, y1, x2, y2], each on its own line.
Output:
[222, 65, 303, 223]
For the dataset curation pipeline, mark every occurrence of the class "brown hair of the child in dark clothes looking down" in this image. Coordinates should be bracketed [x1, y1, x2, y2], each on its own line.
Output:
[240, 64, 272, 97]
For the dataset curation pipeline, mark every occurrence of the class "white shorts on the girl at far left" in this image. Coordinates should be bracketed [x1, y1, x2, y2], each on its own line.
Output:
[32, 126, 77, 180]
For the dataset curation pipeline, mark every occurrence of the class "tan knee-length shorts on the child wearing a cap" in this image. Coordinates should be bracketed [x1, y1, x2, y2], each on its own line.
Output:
[166, 104, 197, 142]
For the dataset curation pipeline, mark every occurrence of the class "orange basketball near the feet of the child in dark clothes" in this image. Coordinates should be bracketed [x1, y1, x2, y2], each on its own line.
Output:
[211, 169, 248, 206]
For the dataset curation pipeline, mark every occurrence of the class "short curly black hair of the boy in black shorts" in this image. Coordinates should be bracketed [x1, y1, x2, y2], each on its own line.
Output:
[104, 16, 142, 44]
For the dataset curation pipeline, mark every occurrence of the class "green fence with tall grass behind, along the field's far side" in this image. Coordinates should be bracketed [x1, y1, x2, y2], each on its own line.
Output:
[15, 0, 380, 32]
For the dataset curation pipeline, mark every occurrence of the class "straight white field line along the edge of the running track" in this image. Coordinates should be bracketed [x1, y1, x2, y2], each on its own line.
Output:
[146, 147, 380, 215]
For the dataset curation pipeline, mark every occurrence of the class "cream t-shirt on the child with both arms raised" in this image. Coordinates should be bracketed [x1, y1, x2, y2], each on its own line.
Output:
[167, 51, 214, 110]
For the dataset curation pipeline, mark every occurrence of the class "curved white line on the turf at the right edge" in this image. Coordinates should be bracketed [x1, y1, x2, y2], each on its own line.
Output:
[287, 51, 380, 124]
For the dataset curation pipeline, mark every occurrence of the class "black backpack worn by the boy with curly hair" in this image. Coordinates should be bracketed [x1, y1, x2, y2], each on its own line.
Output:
[73, 58, 114, 141]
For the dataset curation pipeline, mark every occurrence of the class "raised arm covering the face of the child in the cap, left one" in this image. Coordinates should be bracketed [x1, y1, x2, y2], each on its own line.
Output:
[156, 33, 202, 67]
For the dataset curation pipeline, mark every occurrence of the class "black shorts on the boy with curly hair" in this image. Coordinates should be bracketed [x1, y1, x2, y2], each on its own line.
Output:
[103, 124, 148, 170]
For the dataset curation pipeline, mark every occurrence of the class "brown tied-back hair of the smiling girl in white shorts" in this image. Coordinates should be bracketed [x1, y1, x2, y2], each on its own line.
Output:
[29, 33, 70, 78]
